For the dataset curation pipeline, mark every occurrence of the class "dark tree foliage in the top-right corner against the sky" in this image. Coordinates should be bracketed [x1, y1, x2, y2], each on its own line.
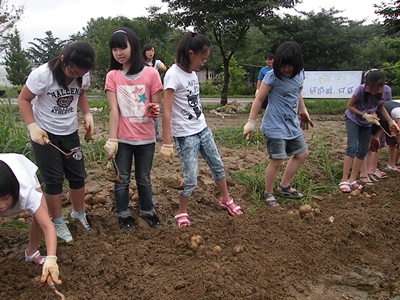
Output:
[374, 0, 400, 35]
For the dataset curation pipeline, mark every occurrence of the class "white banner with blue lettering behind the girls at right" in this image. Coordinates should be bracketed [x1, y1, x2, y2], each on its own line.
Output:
[302, 71, 362, 99]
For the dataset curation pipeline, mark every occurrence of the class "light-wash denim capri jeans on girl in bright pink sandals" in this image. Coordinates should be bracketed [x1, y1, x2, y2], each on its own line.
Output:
[174, 127, 225, 197]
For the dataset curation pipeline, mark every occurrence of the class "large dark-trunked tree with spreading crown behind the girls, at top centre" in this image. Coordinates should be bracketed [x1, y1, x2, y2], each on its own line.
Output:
[162, 0, 300, 105]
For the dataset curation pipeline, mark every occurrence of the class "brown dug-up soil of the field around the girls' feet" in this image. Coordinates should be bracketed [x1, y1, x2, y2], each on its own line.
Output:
[0, 114, 400, 300]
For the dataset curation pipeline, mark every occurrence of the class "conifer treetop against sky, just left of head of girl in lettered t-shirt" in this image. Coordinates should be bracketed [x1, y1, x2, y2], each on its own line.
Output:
[28, 31, 68, 66]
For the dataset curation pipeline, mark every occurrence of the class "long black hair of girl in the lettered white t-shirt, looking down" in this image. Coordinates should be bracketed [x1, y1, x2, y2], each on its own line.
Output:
[48, 41, 96, 90]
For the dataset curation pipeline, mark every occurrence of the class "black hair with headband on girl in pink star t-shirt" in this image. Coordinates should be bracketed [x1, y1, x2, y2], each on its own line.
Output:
[108, 27, 144, 75]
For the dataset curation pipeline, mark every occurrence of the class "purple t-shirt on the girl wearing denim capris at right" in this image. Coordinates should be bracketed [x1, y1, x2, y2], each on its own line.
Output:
[344, 84, 392, 127]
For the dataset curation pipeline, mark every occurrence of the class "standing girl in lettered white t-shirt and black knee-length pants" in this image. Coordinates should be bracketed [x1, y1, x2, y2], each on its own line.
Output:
[18, 41, 96, 243]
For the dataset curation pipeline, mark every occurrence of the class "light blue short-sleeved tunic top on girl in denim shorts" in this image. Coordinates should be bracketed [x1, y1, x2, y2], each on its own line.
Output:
[260, 70, 304, 140]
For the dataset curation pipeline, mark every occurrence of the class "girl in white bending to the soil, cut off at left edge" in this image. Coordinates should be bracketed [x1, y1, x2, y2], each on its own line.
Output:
[0, 153, 61, 284]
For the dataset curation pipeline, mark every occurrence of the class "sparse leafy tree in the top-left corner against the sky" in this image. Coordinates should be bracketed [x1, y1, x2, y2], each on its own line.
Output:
[0, 0, 24, 53]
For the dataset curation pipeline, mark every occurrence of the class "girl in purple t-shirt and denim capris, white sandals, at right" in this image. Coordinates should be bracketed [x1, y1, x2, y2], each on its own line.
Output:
[339, 70, 399, 193]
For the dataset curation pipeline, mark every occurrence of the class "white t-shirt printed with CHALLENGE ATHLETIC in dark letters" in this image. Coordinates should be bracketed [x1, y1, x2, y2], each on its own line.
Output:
[26, 63, 90, 135]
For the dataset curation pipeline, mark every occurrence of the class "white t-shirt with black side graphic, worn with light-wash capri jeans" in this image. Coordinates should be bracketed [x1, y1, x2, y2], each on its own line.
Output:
[164, 64, 207, 137]
